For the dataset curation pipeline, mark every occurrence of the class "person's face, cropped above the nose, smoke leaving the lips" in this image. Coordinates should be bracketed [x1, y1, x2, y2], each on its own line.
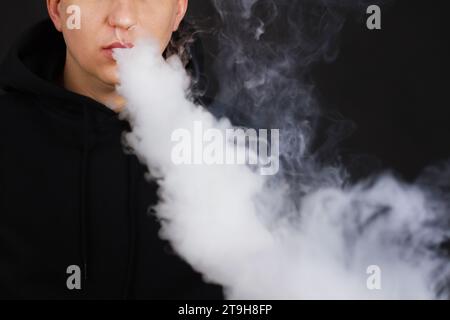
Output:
[47, 0, 188, 85]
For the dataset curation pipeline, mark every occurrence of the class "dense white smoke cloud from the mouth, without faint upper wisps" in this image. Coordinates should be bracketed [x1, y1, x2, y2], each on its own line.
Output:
[115, 41, 450, 299]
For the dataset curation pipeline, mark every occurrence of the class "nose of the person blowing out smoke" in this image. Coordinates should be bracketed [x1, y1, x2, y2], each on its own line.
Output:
[108, 0, 137, 30]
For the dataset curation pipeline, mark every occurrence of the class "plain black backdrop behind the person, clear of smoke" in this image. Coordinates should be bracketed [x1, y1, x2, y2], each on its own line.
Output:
[0, 0, 450, 179]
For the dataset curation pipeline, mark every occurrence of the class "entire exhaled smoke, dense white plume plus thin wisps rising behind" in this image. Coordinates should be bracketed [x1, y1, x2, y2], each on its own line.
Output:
[115, 0, 450, 299]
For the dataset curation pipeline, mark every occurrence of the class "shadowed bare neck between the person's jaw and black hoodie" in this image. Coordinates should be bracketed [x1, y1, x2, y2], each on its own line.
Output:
[64, 52, 125, 112]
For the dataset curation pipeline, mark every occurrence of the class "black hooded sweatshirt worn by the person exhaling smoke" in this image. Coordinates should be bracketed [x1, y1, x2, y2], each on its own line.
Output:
[0, 20, 223, 299]
